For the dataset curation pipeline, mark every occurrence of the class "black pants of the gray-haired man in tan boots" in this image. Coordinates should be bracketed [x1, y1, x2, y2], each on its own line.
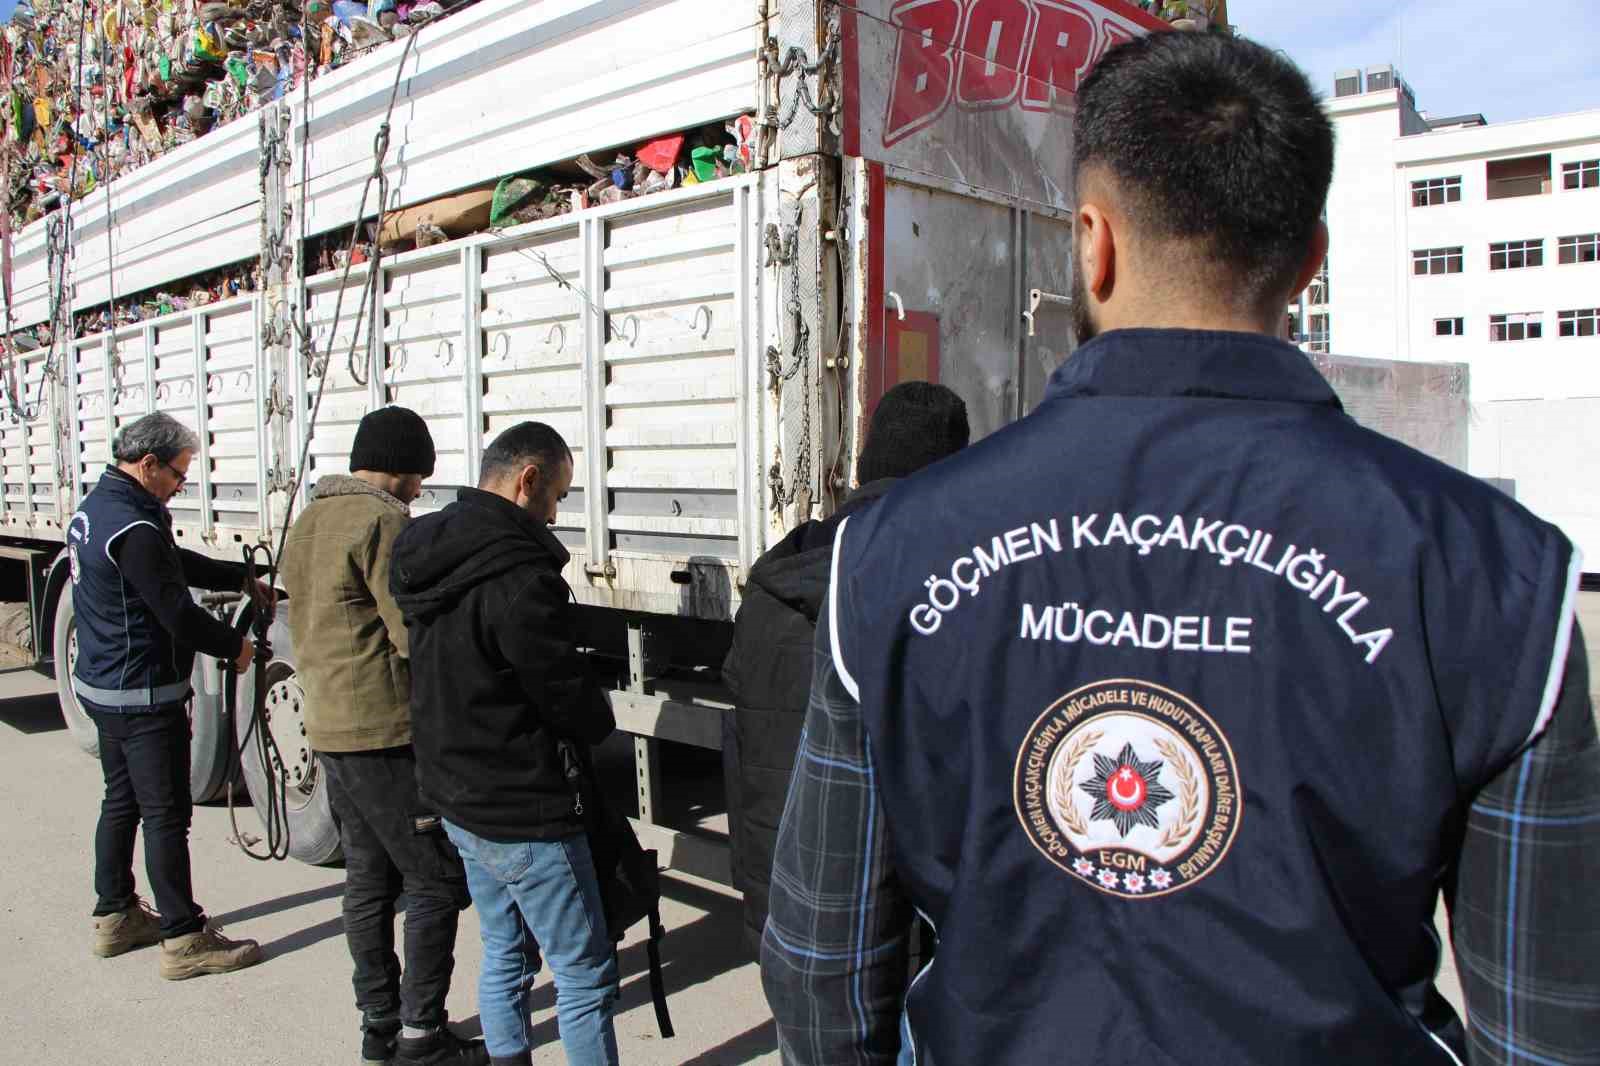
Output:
[85, 703, 205, 940]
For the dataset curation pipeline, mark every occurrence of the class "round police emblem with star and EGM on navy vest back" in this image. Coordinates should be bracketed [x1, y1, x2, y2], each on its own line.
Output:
[1014, 680, 1245, 900]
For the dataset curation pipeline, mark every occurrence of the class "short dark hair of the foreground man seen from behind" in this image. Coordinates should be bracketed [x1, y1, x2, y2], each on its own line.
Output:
[1072, 32, 1333, 306]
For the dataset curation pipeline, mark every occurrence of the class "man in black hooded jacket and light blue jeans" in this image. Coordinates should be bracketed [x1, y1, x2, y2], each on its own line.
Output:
[389, 423, 618, 1066]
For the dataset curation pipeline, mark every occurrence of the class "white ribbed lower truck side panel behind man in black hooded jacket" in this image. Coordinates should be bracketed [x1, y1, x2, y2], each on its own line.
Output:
[297, 176, 771, 618]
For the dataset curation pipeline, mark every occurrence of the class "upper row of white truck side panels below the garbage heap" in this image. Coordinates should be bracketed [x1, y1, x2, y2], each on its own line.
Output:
[13, 0, 763, 328]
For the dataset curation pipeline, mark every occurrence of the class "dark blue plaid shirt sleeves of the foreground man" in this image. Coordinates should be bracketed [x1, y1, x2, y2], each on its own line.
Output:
[762, 610, 1600, 1066]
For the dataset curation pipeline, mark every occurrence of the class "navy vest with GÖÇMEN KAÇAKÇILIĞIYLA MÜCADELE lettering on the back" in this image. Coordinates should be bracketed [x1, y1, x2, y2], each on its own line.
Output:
[830, 330, 1579, 1066]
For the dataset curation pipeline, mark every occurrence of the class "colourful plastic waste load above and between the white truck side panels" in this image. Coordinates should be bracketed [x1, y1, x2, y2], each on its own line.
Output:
[0, 0, 755, 343]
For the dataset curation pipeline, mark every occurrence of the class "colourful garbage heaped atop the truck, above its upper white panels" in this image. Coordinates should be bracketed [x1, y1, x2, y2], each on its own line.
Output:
[0, 0, 474, 227]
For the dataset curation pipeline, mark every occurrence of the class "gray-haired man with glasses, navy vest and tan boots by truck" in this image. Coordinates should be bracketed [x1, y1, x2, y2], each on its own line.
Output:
[67, 413, 270, 981]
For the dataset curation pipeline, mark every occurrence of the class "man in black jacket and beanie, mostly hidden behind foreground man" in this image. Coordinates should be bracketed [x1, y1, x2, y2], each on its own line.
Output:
[722, 381, 970, 954]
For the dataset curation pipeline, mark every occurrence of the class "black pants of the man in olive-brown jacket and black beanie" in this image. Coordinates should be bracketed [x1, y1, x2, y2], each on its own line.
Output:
[320, 746, 472, 1028]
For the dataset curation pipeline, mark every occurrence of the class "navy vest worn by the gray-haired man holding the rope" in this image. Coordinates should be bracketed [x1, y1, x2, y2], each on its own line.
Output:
[67, 467, 195, 712]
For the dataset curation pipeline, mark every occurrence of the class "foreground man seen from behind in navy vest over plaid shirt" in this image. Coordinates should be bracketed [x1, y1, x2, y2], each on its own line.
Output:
[762, 34, 1600, 1066]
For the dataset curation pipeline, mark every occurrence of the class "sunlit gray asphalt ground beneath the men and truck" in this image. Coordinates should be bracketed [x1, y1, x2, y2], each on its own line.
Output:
[0, 594, 1600, 1066]
